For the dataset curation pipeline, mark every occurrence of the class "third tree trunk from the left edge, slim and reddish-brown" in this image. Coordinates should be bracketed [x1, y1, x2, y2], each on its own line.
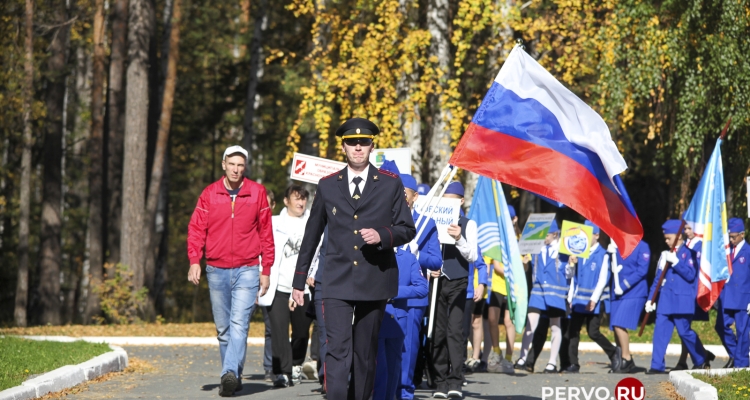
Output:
[83, 0, 106, 324]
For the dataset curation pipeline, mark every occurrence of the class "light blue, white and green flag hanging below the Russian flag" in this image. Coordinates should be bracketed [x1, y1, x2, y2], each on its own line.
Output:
[468, 176, 528, 333]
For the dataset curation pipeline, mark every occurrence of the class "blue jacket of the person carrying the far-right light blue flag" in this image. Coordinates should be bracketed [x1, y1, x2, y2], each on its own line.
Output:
[648, 244, 699, 316]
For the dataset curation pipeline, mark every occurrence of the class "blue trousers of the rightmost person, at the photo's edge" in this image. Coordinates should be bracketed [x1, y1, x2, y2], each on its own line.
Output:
[714, 307, 750, 368]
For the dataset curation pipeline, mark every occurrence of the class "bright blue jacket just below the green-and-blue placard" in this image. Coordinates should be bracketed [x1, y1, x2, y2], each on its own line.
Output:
[529, 241, 569, 310]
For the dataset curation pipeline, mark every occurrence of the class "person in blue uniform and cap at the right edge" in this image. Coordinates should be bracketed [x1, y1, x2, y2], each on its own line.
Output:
[716, 218, 750, 368]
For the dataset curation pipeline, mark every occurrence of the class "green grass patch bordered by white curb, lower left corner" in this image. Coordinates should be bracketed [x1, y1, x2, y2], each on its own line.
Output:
[0, 337, 111, 390]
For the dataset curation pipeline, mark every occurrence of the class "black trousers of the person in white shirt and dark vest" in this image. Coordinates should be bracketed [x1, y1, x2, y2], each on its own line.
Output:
[432, 276, 469, 389]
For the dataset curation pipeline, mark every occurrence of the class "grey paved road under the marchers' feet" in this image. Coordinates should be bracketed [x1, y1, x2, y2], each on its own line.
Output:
[68, 346, 726, 400]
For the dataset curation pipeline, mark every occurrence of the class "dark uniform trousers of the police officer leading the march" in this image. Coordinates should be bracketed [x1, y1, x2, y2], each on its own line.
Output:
[323, 299, 386, 400]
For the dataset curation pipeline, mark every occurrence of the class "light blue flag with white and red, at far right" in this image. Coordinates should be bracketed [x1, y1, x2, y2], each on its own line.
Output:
[683, 139, 731, 311]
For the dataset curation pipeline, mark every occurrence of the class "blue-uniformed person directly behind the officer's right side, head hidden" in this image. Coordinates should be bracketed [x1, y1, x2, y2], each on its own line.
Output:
[372, 247, 428, 400]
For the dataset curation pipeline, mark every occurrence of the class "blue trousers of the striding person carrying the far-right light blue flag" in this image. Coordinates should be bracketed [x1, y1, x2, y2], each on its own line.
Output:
[651, 313, 706, 371]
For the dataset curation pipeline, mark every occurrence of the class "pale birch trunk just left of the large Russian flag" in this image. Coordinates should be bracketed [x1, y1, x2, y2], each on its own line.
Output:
[427, 0, 451, 182]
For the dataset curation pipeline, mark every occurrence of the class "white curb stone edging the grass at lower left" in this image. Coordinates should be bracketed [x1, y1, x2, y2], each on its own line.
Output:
[0, 338, 128, 400]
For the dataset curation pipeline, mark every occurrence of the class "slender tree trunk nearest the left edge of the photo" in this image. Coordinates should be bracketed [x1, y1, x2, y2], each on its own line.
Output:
[13, 0, 34, 326]
